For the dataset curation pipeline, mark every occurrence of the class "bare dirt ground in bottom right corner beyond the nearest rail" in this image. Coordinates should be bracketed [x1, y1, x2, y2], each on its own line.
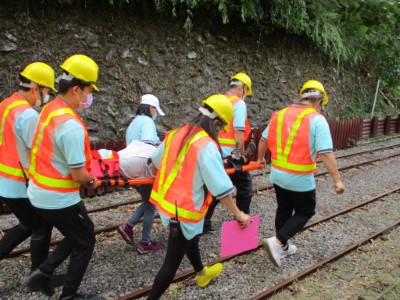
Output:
[271, 227, 400, 300]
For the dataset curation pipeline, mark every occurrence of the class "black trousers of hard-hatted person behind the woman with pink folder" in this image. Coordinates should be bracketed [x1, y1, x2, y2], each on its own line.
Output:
[204, 172, 253, 226]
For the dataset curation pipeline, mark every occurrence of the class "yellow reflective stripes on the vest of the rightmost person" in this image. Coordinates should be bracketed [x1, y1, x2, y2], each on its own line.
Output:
[271, 108, 317, 174]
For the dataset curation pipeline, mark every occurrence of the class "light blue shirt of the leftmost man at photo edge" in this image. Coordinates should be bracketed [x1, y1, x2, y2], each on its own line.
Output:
[0, 108, 39, 198]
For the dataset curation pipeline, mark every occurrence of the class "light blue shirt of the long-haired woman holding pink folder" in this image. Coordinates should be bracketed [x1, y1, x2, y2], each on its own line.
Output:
[152, 141, 233, 240]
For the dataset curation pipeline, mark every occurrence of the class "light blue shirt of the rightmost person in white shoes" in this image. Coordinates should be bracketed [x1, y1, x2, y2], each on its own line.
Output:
[261, 108, 333, 192]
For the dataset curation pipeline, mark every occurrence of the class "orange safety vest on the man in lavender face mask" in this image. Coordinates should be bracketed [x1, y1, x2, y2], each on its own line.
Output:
[29, 97, 91, 192]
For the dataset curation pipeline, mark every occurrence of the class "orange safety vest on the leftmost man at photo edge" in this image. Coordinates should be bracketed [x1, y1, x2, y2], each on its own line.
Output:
[0, 93, 31, 182]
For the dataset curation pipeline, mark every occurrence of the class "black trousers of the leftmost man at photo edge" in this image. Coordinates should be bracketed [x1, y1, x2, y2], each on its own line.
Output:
[0, 197, 52, 271]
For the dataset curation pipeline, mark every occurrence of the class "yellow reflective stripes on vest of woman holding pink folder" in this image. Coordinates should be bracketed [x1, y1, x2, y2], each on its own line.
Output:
[150, 129, 212, 223]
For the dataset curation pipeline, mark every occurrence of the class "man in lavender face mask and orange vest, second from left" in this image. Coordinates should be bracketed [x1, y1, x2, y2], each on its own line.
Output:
[27, 54, 99, 299]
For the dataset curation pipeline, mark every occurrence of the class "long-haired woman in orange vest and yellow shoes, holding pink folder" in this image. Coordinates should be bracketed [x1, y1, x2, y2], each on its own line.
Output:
[148, 95, 250, 299]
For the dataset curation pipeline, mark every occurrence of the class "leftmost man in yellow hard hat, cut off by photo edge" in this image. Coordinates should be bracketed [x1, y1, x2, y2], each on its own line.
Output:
[0, 62, 55, 271]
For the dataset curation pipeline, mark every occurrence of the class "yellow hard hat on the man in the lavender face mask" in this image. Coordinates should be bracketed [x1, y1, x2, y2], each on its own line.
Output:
[60, 54, 99, 91]
